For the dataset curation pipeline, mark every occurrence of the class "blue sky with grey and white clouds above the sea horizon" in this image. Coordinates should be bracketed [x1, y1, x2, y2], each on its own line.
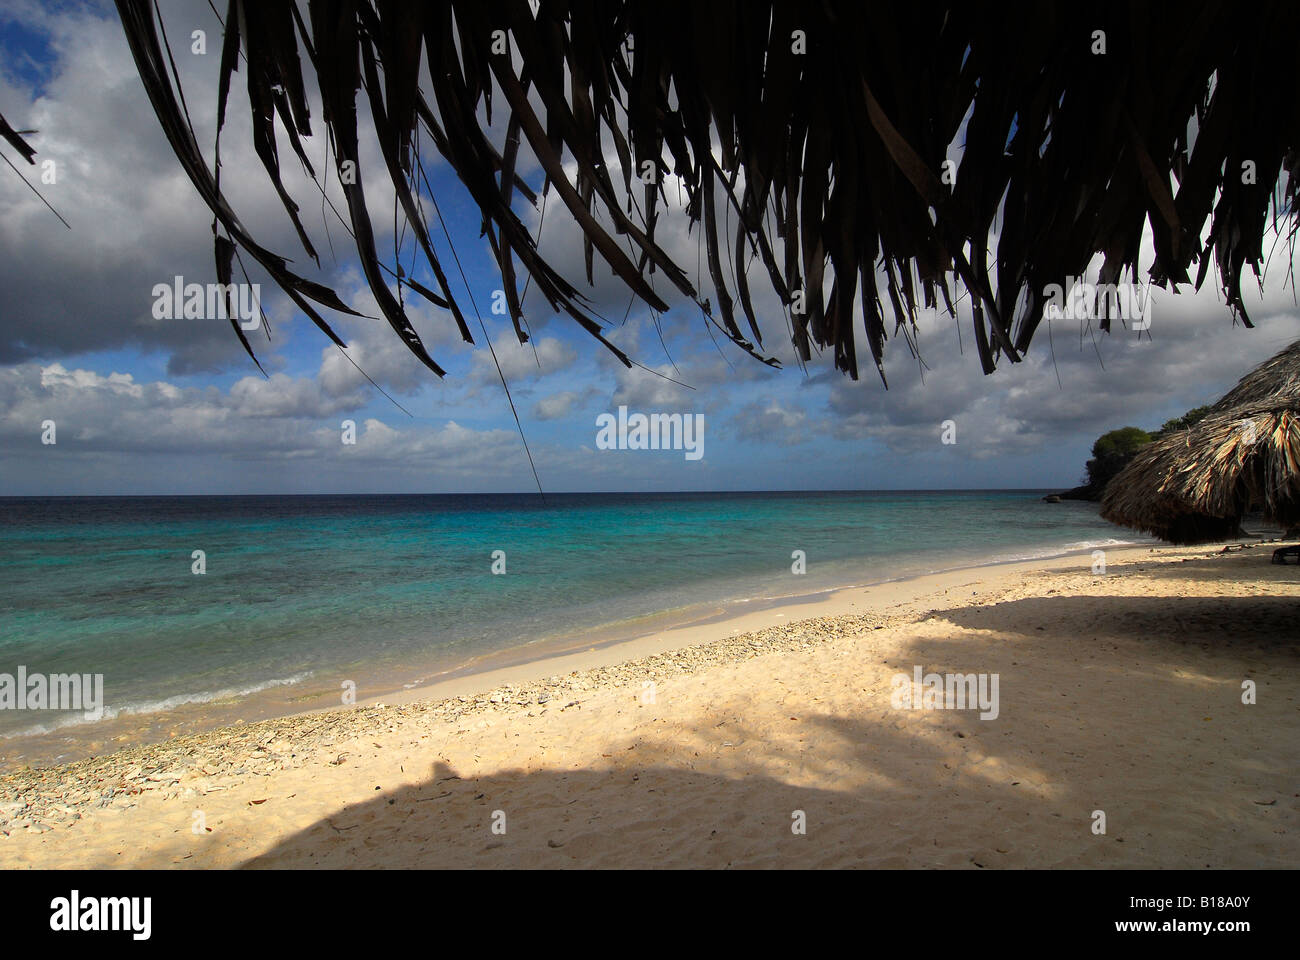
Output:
[0, 0, 1300, 494]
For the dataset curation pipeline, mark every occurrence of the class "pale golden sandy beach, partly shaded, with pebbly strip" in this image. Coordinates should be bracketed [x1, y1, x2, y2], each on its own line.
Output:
[0, 546, 1300, 869]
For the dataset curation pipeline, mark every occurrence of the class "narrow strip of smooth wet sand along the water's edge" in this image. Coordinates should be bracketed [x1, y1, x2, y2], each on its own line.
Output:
[0, 541, 1152, 777]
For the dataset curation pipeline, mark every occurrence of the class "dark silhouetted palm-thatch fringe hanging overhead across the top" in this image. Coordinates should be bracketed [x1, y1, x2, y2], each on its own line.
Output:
[76, 0, 1300, 377]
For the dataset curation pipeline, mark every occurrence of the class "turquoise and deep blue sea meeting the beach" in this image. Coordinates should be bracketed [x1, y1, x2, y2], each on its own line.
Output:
[0, 490, 1134, 736]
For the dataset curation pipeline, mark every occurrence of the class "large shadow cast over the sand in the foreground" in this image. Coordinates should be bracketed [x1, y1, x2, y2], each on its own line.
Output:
[200, 582, 1300, 869]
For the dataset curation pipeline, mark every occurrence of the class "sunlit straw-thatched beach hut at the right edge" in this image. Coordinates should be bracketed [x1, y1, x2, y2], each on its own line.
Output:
[1101, 341, 1300, 544]
